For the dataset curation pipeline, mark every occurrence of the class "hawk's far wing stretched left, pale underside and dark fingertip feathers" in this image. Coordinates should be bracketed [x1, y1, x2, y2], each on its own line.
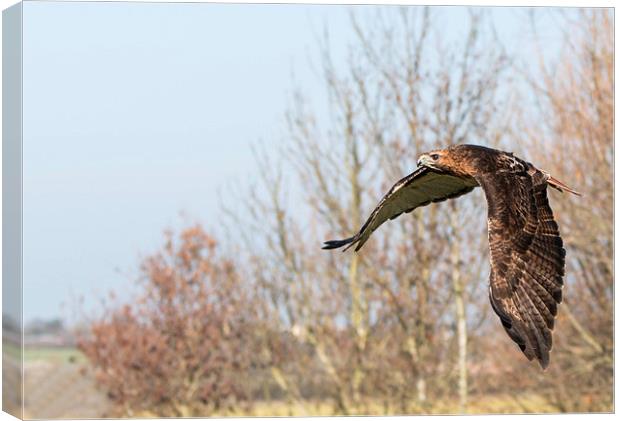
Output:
[323, 167, 478, 251]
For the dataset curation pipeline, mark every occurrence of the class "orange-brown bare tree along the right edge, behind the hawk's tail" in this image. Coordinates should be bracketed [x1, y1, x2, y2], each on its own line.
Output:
[524, 9, 614, 411]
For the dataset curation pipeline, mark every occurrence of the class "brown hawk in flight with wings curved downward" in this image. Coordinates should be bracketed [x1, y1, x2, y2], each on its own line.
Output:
[323, 145, 579, 369]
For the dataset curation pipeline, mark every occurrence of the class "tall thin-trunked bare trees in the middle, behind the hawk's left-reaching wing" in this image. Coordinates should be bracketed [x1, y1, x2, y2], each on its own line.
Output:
[225, 8, 508, 414]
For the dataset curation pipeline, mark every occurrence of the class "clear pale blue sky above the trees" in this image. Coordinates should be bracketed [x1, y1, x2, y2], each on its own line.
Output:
[17, 1, 572, 322]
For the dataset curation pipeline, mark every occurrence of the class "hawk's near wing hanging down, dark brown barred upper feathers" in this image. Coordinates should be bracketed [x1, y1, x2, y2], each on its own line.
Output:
[477, 167, 566, 368]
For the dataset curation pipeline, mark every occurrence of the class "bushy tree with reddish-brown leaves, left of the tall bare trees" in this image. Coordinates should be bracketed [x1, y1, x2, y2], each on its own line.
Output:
[79, 226, 260, 416]
